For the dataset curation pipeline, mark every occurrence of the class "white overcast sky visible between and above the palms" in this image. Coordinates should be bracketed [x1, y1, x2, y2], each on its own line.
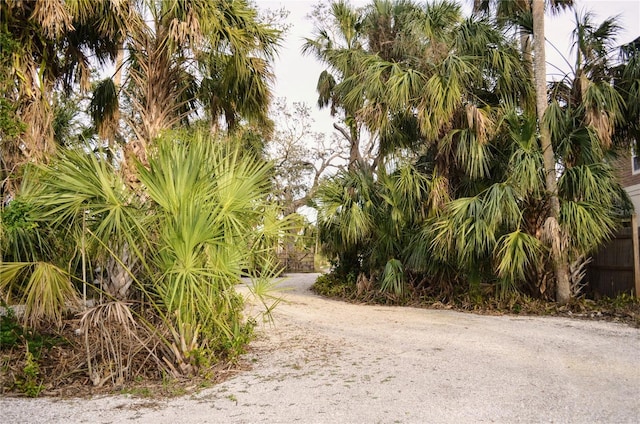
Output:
[254, 0, 640, 134]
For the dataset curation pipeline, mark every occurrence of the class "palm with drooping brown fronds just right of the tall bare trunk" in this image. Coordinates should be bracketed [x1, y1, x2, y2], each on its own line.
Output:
[545, 12, 635, 288]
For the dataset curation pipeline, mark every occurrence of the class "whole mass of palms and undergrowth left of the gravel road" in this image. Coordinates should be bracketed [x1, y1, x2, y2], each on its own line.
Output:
[0, 0, 290, 396]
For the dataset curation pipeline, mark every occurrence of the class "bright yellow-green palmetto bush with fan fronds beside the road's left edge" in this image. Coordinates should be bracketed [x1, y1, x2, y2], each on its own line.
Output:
[0, 133, 283, 384]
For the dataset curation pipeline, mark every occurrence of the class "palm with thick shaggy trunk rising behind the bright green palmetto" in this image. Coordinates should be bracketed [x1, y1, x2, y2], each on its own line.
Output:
[93, 0, 280, 174]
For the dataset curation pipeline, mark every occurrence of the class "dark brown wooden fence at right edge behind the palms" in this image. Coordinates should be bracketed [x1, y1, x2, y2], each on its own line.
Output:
[587, 215, 640, 297]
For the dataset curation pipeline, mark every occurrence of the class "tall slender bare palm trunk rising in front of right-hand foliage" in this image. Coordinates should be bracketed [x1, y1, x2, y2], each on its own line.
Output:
[531, 0, 571, 305]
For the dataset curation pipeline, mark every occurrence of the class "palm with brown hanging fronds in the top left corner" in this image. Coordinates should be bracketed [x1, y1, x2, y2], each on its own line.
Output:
[0, 0, 128, 195]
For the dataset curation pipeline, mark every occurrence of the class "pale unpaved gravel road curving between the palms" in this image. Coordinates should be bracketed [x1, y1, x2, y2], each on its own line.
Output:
[0, 274, 640, 424]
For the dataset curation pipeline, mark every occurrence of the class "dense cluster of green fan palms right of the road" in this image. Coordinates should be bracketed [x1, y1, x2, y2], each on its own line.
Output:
[307, 1, 637, 304]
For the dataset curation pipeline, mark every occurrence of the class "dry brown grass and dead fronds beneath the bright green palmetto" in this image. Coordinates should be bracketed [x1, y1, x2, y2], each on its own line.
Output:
[0, 316, 248, 398]
